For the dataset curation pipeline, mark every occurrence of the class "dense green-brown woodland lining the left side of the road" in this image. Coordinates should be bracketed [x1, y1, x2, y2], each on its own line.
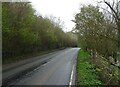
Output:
[2, 2, 77, 60]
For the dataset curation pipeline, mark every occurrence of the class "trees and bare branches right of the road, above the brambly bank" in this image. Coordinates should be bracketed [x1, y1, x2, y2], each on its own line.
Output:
[73, 0, 120, 65]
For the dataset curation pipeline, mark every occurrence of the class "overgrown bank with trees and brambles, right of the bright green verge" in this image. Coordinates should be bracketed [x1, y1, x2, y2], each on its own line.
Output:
[73, 0, 120, 85]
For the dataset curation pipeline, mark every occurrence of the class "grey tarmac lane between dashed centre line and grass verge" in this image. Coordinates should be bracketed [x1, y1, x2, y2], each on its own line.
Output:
[3, 48, 79, 85]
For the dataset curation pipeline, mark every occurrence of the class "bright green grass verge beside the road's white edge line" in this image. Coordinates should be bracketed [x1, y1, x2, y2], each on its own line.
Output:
[77, 50, 102, 86]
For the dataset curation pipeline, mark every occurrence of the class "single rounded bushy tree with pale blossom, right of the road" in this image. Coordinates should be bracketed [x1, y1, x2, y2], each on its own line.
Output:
[74, 5, 117, 58]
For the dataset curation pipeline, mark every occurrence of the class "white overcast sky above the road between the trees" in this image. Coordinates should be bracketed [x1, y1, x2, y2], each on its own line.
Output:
[29, 0, 100, 31]
